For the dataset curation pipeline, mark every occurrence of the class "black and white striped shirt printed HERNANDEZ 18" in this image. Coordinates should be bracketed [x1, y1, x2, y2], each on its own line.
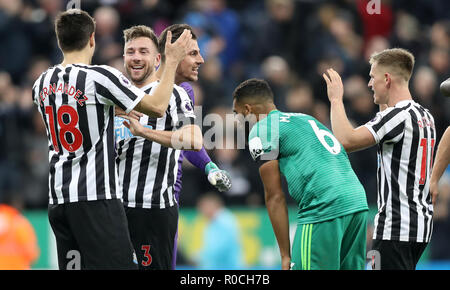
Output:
[32, 64, 145, 204]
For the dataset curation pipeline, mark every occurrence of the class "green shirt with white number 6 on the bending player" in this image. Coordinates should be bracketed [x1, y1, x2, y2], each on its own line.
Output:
[249, 110, 368, 224]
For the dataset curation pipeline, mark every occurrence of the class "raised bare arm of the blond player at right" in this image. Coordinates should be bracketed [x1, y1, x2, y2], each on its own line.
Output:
[323, 69, 381, 152]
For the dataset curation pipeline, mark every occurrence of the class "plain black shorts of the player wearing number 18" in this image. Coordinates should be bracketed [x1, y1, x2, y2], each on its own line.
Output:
[48, 199, 138, 270]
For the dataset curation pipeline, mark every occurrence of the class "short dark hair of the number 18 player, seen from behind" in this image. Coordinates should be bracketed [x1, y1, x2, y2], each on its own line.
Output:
[55, 9, 95, 52]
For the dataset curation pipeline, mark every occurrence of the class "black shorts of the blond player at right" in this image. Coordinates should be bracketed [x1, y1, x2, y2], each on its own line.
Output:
[372, 240, 428, 270]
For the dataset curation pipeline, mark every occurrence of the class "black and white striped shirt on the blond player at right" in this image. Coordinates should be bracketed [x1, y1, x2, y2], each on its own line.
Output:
[364, 101, 436, 242]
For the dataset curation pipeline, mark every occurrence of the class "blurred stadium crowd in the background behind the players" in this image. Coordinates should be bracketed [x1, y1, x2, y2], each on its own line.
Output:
[0, 0, 450, 258]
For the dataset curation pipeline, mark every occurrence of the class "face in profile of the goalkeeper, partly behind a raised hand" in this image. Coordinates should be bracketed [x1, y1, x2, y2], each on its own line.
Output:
[175, 39, 205, 84]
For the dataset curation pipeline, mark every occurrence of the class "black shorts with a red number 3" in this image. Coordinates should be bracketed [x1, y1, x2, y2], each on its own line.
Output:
[125, 205, 178, 270]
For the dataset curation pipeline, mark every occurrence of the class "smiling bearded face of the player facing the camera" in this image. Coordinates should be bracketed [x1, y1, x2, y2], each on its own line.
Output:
[124, 37, 161, 85]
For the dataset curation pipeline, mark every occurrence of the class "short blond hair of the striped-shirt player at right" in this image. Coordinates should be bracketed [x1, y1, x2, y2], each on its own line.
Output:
[369, 48, 415, 82]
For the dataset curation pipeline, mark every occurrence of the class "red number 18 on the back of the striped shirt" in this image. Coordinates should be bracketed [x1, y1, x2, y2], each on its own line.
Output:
[45, 105, 83, 152]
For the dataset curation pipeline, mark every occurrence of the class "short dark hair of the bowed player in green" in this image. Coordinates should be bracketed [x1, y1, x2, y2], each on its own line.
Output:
[233, 78, 273, 103]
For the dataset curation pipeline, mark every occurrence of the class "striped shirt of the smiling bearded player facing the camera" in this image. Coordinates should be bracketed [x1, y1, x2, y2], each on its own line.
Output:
[115, 82, 195, 208]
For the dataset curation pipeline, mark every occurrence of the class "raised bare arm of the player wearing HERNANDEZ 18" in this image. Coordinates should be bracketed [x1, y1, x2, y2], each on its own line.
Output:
[135, 29, 192, 118]
